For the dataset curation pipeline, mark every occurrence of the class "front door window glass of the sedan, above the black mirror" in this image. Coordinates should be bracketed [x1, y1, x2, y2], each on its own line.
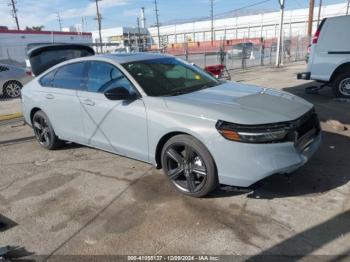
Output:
[86, 62, 135, 93]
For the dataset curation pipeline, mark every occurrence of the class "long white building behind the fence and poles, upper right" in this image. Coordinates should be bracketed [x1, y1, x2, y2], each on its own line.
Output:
[148, 3, 347, 44]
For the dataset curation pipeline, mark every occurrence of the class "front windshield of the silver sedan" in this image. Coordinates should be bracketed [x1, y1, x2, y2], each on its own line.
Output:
[123, 57, 220, 96]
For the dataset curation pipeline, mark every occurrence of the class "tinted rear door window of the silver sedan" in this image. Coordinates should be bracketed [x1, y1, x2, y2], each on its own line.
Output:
[53, 63, 85, 89]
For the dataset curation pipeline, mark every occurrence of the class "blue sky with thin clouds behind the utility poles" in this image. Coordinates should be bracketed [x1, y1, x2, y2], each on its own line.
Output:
[0, 0, 346, 30]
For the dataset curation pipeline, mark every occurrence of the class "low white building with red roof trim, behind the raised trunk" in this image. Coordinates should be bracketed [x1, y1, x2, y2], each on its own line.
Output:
[0, 29, 92, 65]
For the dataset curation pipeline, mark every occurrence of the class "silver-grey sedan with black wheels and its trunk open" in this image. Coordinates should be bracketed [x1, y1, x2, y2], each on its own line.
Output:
[22, 46, 321, 197]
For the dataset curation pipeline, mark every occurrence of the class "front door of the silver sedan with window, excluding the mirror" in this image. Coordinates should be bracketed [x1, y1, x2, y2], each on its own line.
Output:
[78, 61, 148, 161]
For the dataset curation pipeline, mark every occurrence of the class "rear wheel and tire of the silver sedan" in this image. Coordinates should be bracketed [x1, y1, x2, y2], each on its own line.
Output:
[32, 110, 63, 150]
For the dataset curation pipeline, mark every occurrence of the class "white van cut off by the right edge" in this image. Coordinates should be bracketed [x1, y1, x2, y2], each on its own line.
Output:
[297, 16, 350, 98]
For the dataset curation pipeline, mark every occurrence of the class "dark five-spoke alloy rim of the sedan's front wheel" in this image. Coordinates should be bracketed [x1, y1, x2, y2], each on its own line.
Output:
[165, 144, 207, 193]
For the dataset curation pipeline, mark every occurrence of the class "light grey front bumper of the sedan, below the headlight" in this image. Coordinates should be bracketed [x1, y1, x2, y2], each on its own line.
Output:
[213, 133, 322, 187]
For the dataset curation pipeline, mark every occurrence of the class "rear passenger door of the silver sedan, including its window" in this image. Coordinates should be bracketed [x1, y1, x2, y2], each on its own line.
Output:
[37, 62, 87, 144]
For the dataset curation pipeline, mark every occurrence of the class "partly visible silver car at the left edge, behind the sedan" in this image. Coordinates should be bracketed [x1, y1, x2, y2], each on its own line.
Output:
[0, 64, 32, 98]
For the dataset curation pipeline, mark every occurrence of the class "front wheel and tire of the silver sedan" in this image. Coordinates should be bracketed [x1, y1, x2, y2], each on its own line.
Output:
[162, 135, 218, 197]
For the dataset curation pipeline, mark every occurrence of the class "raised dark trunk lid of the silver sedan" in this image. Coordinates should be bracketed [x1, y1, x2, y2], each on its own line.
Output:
[28, 44, 95, 76]
